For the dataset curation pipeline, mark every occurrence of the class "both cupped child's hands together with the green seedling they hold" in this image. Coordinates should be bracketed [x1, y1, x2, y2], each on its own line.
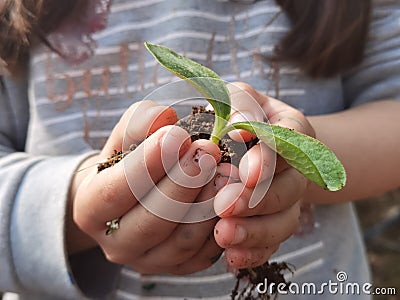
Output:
[68, 44, 345, 297]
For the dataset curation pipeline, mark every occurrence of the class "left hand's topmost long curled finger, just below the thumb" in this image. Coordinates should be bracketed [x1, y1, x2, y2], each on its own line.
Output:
[74, 126, 190, 234]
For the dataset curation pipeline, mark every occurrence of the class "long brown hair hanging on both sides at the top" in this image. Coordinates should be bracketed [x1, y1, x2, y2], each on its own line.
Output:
[0, 0, 371, 77]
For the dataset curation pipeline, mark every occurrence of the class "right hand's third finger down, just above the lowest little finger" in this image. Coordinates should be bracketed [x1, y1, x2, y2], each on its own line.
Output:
[214, 202, 300, 248]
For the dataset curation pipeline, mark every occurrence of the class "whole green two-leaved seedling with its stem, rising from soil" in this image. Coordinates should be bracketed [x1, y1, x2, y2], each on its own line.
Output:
[145, 42, 346, 191]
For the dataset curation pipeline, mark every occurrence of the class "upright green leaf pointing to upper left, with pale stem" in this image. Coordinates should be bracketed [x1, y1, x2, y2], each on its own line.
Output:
[145, 42, 231, 143]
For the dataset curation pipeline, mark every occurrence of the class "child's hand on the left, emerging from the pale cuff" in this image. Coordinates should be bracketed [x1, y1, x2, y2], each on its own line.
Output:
[72, 101, 231, 274]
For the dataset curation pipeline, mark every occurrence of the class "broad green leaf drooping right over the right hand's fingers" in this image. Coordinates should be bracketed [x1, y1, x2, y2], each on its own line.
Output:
[224, 122, 346, 191]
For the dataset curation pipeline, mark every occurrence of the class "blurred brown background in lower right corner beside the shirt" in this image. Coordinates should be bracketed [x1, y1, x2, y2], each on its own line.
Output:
[356, 189, 400, 300]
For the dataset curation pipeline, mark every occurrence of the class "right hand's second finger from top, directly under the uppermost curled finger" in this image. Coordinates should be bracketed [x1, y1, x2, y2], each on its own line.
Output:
[214, 168, 308, 218]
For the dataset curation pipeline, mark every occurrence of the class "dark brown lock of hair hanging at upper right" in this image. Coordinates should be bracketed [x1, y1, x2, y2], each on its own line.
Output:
[273, 0, 371, 77]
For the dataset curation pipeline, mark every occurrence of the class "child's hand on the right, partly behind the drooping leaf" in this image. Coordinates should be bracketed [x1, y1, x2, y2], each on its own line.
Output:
[214, 83, 315, 268]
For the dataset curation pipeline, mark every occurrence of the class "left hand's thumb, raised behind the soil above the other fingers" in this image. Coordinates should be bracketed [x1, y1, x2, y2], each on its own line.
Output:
[102, 100, 178, 157]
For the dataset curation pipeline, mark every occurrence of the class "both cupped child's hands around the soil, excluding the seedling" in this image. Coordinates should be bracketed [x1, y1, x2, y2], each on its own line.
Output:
[69, 83, 315, 274]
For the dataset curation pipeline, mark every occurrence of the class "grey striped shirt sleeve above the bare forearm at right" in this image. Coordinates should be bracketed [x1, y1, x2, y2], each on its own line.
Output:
[343, 0, 400, 107]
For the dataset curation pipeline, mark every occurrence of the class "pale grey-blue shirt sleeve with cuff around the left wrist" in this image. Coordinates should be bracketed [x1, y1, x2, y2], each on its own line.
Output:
[0, 77, 120, 299]
